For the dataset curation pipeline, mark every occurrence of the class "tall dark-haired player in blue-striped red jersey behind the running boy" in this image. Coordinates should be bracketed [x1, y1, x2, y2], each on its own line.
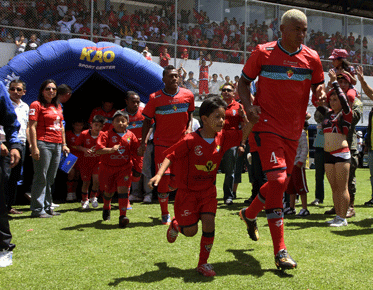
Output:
[139, 65, 194, 225]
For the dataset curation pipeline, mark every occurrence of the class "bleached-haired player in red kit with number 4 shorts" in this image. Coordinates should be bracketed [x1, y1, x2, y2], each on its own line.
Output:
[238, 9, 326, 269]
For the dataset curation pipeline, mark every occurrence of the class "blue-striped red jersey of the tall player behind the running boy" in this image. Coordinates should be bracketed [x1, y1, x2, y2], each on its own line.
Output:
[142, 88, 194, 146]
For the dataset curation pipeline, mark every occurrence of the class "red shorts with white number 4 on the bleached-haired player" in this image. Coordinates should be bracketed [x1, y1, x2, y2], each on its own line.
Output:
[255, 133, 298, 177]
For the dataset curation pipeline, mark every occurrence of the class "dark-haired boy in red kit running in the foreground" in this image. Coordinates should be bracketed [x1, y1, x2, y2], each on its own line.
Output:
[149, 97, 252, 276]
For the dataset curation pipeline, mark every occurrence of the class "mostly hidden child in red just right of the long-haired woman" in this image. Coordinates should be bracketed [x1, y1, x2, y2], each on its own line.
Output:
[66, 120, 84, 201]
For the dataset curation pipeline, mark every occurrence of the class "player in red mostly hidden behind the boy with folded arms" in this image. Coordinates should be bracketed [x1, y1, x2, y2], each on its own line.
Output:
[122, 91, 152, 203]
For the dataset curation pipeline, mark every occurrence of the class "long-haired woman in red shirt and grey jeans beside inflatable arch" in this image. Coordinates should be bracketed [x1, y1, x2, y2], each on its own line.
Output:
[29, 80, 70, 218]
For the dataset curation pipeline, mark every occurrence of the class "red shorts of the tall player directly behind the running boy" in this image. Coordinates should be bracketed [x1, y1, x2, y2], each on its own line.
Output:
[154, 145, 177, 193]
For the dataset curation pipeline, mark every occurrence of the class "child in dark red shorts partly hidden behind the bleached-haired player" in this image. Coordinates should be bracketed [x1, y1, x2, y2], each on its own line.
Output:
[284, 121, 310, 217]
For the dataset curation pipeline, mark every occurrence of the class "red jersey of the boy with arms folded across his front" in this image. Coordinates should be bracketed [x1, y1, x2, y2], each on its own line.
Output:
[96, 129, 141, 172]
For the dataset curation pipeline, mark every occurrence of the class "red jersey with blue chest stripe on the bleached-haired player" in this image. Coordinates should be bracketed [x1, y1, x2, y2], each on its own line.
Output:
[242, 40, 324, 141]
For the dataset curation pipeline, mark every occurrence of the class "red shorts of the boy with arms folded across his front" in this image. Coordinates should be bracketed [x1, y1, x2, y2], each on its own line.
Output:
[98, 163, 132, 193]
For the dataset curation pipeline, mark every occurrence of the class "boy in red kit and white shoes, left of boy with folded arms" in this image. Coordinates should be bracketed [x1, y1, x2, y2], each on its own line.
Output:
[75, 115, 106, 209]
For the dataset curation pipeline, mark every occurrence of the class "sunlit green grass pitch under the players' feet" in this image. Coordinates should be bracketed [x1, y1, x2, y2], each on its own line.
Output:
[0, 169, 373, 289]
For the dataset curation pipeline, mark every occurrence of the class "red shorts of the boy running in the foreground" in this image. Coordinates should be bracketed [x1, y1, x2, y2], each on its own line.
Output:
[174, 186, 218, 227]
